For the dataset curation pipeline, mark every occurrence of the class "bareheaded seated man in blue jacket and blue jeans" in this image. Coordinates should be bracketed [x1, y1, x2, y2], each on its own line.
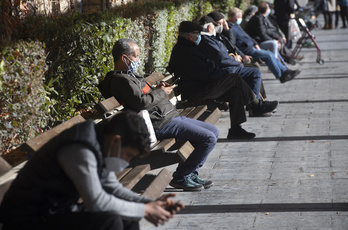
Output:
[224, 7, 300, 83]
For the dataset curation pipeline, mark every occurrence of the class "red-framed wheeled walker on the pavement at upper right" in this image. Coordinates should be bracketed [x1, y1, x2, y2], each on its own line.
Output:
[291, 9, 325, 65]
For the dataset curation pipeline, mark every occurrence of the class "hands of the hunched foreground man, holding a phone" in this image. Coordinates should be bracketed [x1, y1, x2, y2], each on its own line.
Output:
[144, 194, 184, 226]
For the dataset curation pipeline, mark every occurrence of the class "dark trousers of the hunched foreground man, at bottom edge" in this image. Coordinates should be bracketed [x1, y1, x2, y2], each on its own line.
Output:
[3, 212, 139, 230]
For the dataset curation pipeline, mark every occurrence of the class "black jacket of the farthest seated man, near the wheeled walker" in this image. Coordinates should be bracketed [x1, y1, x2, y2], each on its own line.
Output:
[245, 12, 281, 43]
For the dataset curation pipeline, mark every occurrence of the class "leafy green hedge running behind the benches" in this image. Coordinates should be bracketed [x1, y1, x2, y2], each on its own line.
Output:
[1, 0, 247, 153]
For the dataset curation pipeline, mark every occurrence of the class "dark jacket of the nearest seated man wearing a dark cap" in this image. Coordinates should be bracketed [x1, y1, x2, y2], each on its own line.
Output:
[169, 37, 228, 99]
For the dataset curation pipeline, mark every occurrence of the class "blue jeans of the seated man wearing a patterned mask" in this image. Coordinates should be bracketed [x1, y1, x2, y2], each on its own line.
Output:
[157, 116, 219, 177]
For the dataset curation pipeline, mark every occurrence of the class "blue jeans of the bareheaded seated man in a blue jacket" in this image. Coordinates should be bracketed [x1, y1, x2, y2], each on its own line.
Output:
[246, 47, 287, 79]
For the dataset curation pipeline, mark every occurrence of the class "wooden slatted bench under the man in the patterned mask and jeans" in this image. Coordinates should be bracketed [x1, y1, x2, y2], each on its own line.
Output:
[96, 72, 221, 169]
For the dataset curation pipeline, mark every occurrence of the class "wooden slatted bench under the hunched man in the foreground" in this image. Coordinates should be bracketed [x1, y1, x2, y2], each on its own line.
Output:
[0, 115, 172, 225]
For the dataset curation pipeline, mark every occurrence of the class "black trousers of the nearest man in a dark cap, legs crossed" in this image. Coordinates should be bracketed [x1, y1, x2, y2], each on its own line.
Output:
[188, 74, 255, 127]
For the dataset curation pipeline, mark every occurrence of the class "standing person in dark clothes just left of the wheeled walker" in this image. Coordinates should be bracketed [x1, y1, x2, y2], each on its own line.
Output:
[274, 0, 295, 49]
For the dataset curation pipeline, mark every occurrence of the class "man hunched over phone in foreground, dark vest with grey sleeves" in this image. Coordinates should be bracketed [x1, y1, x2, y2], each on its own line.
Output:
[0, 112, 183, 230]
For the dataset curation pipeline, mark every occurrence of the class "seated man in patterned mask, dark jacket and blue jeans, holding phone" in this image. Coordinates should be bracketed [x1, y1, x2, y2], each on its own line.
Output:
[99, 39, 219, 191]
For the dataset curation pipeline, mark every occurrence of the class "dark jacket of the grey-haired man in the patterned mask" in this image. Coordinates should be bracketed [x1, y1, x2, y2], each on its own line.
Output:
[98, 71, 179, 130]
